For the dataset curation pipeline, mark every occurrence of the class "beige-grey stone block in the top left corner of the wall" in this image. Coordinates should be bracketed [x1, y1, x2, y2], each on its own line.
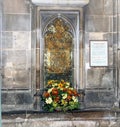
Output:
[3, 0, 30, 13]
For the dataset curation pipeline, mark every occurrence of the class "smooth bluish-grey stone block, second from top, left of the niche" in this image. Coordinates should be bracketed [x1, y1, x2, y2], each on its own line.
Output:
[2, 14, 30, 31]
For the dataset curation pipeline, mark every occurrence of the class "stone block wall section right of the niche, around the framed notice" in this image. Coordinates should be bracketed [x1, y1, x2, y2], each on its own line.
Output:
[84, 0, 118, 108]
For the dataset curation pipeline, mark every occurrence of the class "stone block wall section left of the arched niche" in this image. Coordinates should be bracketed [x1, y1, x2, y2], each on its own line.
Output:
[1, 0, 33, 111]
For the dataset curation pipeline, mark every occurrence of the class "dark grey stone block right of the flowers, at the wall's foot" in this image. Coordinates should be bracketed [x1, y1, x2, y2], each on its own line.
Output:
[85, 90, 116, 109]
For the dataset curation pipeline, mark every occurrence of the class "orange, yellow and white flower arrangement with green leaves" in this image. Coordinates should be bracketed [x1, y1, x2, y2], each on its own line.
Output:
[42, 80, 79, 112]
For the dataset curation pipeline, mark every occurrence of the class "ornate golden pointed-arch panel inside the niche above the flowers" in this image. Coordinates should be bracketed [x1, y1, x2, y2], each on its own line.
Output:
[44, 17, 74, 83]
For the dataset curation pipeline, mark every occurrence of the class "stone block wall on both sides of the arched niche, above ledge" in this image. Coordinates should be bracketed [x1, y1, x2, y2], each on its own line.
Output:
[1, 0, 119, 110]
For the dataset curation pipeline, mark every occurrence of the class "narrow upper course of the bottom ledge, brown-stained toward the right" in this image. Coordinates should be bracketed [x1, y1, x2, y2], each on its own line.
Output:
[2, 111, 116, 121]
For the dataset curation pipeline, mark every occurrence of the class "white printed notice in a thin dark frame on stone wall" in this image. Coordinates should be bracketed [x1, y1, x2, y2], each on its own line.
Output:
[90, 40, 108, 66]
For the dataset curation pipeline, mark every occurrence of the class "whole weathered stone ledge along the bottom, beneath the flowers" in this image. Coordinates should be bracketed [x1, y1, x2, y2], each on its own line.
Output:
[2, 111, 120, 127]
